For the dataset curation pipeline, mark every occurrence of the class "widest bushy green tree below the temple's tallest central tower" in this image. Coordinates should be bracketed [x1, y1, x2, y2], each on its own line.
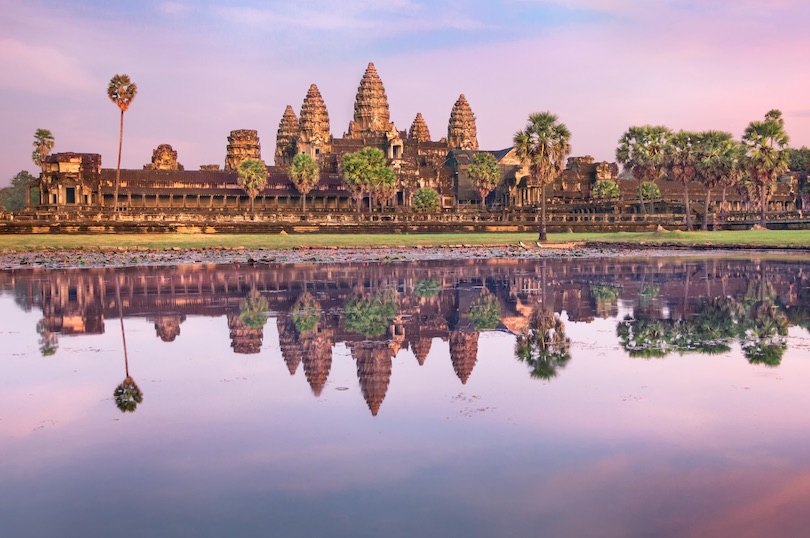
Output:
[340, 148, 396, 213]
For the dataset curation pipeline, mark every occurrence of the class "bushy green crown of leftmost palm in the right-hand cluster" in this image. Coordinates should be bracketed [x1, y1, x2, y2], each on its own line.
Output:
[616, 125, 672, 212]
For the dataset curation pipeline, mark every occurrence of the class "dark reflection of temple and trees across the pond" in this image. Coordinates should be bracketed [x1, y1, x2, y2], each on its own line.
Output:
[0, 258, 810, 415]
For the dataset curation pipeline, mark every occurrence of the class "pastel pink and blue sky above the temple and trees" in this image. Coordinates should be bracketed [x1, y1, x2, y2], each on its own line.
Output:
[0, 0, 810, 186]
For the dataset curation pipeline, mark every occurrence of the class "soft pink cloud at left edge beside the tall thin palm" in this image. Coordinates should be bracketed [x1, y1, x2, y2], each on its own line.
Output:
[0, 38, 99, 97]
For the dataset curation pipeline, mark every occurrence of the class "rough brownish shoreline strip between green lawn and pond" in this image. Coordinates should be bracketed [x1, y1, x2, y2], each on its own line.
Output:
[0, 242, 810, 271]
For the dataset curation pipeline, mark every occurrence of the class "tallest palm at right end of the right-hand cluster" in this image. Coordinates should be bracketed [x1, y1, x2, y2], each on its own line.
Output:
[742, 110, 790, 227]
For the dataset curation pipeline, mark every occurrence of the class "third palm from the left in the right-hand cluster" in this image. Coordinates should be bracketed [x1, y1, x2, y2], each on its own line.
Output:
[695, 131, 739, 231]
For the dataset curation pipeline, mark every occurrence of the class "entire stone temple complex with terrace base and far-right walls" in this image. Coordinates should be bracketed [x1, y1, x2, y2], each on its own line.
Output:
[25, 63, 798, 224]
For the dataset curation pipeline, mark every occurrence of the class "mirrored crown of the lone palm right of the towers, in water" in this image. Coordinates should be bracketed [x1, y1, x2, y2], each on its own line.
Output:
[515, 309, 571, 380]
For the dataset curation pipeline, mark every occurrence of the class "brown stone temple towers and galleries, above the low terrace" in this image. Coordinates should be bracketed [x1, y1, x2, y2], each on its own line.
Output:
[26, 63, 617, 214]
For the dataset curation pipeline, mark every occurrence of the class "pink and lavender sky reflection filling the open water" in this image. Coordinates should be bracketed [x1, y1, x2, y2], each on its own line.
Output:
[0, 297, 810, 536]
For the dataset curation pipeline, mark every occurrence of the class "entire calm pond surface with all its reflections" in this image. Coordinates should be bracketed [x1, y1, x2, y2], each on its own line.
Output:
[0, 256, 810, 537]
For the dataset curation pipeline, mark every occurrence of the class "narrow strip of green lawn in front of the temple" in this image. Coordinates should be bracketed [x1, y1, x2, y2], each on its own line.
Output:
[0, 230, 810, 252]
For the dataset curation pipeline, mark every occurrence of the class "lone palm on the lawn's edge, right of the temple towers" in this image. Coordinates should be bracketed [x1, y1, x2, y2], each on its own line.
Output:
[514, 112, 571, 241]
